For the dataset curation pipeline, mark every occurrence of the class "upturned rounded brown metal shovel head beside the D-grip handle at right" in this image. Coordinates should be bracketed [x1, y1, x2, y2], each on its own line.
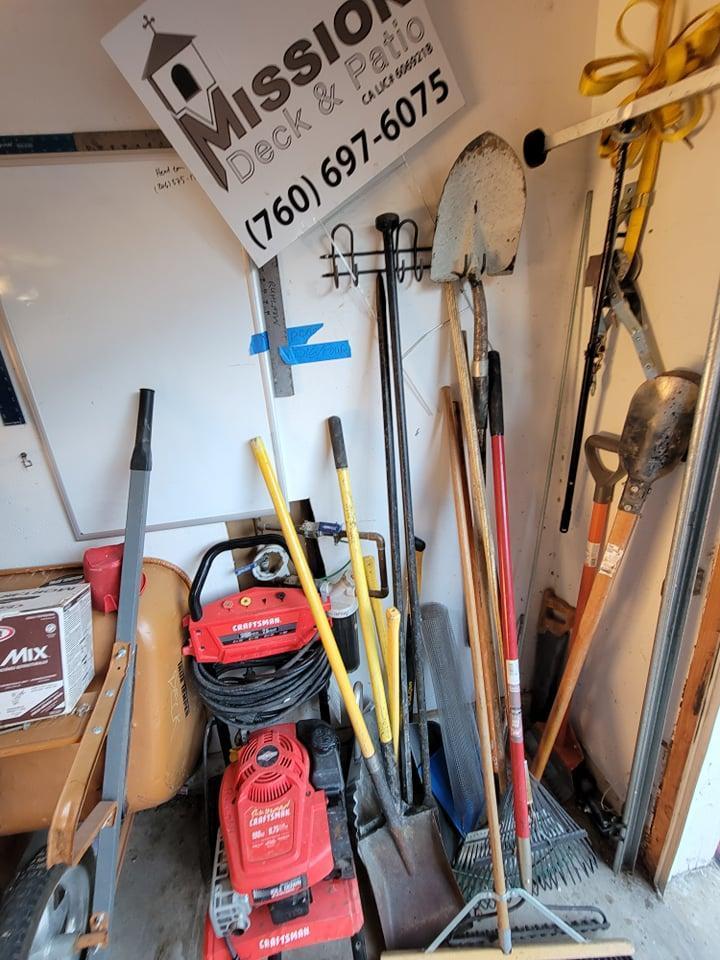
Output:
[620, 371, 698, 486]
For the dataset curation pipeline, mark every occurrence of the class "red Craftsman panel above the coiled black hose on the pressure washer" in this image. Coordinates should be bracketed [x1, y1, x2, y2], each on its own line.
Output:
[183, 587, 330, 663]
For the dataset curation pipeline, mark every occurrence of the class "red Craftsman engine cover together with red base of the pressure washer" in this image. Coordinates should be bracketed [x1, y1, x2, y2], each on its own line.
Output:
[203, 724, 363, 960]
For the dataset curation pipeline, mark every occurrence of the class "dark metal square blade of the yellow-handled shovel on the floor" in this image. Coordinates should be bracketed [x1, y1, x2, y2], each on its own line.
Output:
[358, 810, 465, 950]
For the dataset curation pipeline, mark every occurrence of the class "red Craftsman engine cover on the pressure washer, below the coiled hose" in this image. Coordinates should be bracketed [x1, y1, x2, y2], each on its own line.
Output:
[220, 724, 333, 905]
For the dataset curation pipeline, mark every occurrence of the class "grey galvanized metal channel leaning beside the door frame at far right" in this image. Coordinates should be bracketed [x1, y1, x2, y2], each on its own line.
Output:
[613, 274, 720, 873]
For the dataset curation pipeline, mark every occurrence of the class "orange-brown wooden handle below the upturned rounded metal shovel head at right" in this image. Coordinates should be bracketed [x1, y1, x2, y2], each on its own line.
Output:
[532, 511, 638, 780]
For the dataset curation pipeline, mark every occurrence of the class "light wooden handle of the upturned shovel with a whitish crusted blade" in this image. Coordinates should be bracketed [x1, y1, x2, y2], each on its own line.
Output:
[443, 283, 502, 728]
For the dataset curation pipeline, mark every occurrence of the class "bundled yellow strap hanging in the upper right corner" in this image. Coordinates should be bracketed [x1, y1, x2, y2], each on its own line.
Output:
[579, 0, 720, 261]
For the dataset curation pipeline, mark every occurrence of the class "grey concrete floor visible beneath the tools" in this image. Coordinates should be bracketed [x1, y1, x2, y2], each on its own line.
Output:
[108, 799, 720, 960]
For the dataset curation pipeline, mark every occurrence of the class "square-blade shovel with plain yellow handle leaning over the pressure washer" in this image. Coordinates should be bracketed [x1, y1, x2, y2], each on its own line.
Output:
[250, 437, 464, 950]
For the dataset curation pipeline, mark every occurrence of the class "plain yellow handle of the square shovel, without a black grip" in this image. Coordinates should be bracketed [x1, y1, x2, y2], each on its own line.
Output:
[250, 437, 375, 760]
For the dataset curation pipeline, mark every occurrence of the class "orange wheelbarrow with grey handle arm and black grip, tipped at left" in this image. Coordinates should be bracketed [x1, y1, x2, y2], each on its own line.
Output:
[0, 389, 205, 960]
